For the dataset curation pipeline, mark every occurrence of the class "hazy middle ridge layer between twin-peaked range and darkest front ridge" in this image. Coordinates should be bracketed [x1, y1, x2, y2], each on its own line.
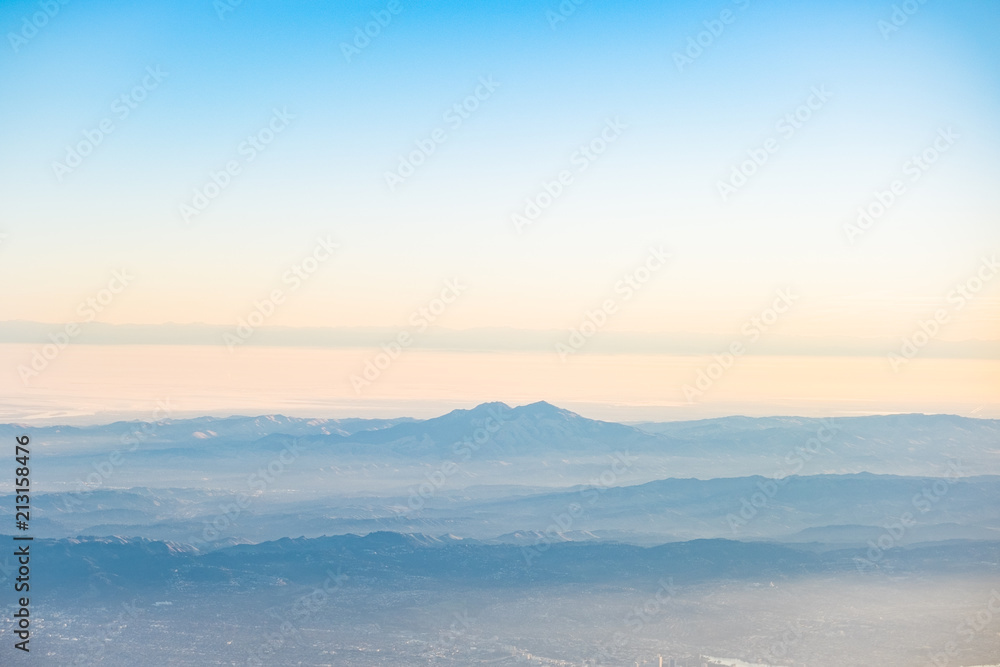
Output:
[0, 473, 1000, 550]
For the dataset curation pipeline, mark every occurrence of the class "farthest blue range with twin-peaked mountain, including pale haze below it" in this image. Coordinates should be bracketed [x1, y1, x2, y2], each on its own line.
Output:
[0, 402, 1000, 493]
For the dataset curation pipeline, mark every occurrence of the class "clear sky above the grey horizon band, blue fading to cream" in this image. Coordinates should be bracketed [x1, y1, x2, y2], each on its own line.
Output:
[0, 0, 1000, 418]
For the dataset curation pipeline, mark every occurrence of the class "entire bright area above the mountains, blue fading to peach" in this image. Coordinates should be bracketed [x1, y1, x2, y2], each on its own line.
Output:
[0, 0, 1000, 418]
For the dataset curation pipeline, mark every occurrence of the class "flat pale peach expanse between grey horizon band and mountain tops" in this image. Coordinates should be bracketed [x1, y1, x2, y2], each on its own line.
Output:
[0, 344, 1000, 423]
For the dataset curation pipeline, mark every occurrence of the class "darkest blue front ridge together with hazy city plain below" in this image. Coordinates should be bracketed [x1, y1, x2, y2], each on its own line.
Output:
[0, 532, 1000, 667]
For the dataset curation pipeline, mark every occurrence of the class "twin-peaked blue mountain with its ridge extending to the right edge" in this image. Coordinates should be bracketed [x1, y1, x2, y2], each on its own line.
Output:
[242, 402, 1000, 474]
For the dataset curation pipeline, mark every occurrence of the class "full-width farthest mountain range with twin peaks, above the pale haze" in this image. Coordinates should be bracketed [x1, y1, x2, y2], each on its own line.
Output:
[7, 402, 1000, 472]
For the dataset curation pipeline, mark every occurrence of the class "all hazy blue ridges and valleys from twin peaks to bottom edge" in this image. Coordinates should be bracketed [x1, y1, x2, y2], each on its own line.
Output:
[0, 403, 1000, 667]
